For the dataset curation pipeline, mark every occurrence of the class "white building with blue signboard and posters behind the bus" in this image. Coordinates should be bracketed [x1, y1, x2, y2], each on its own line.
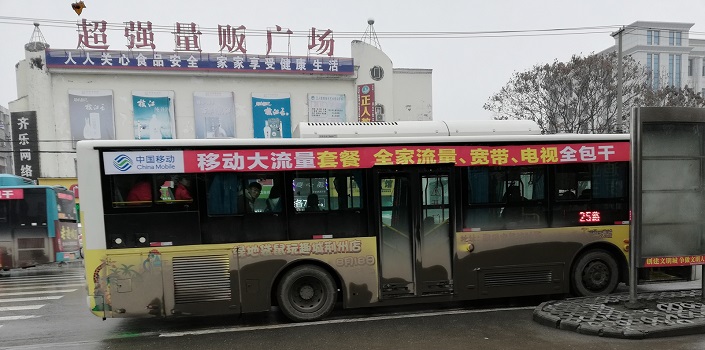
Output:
[10, 24, 432, 187]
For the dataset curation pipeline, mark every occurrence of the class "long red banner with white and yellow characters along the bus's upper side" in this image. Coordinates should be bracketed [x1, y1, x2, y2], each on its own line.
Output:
[184, 142, 629, 173]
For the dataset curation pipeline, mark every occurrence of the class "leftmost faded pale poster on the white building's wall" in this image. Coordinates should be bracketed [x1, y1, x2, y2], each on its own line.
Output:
[69, 90, 115, 141]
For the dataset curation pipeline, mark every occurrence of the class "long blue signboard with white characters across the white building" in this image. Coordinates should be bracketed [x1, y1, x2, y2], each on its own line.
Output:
[46, 50, 354, 75]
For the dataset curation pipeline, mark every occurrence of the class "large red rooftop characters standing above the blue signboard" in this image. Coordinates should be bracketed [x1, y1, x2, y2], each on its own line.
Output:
[77, 18, 335, 57]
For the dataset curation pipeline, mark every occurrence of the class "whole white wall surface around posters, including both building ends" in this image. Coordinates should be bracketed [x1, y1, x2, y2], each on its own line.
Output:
[10, 41, 432, 178]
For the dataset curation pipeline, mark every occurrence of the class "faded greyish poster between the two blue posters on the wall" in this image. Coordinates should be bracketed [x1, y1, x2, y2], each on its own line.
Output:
[193, 92, 235, 139]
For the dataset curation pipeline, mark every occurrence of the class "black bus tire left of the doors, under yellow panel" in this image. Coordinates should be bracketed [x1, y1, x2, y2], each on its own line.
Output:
[277, 265, 338, 322]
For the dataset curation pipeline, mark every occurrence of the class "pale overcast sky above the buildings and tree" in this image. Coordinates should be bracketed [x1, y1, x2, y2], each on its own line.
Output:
[0, 0, 705, 120]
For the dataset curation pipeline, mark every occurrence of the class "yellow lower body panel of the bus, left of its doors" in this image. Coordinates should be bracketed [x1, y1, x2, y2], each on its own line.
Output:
[86, 237, 379, 317]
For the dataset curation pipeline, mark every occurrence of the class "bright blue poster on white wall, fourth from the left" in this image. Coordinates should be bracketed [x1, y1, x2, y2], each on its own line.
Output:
[252, 93, 291, 139]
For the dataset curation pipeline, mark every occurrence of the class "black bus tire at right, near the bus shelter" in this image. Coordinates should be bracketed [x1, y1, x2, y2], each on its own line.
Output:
[571, 250, 619, 296]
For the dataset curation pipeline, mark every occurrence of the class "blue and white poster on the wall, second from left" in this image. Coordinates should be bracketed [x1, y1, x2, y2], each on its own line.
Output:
[132, 91, 176, 140]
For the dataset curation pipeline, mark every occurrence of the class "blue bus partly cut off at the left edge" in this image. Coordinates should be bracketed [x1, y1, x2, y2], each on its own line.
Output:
[0, 174, 80, 270]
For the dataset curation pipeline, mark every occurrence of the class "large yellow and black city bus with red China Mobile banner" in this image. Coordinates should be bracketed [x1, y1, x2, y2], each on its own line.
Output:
[77, 121, 630, 321]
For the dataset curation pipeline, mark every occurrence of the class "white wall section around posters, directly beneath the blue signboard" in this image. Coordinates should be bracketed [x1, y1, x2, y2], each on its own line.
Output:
[52, 73, 357, 139]
